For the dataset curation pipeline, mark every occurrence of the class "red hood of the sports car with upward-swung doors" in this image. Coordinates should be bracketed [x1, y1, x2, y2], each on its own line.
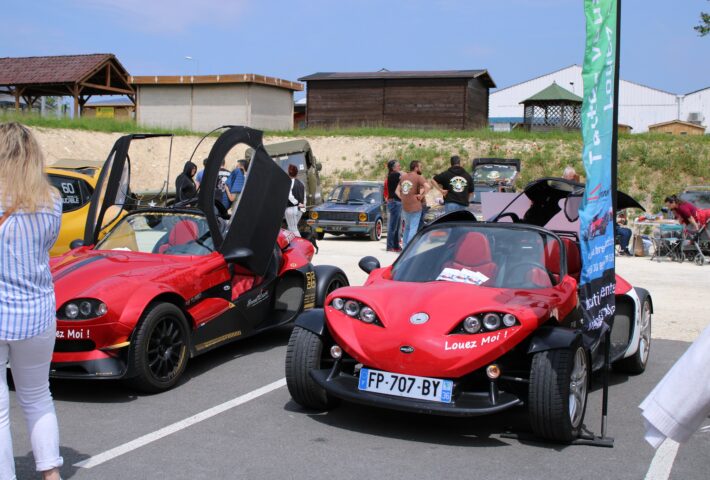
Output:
[50, 248, 204, 307]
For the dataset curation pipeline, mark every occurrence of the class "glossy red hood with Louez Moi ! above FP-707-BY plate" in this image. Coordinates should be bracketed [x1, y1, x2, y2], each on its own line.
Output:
[325, 280, 576, 378]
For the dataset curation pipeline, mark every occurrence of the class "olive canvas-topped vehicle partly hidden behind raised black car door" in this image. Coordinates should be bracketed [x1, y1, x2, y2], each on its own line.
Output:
[245, 140, 323, 232]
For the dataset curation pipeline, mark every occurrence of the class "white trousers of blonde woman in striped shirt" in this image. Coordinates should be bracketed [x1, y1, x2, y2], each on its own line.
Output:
[0, 325, 64, 480]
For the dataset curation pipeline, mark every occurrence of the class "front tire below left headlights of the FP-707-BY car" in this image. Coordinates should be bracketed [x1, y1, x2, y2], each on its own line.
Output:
[286, 327, 340, 411]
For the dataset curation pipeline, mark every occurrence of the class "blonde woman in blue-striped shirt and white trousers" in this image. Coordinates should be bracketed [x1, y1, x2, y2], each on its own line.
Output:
[0, 123, 63, 480]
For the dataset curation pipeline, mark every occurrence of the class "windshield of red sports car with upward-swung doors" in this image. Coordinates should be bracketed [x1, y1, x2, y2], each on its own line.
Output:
[96, 212, 214, 255]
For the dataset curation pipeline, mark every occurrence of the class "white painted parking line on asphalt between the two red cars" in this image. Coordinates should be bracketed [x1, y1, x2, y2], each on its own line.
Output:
[74, 378, 286, 468]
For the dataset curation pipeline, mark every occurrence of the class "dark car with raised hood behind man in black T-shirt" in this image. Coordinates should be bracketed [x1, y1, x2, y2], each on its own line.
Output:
[424, 158, 520, 223]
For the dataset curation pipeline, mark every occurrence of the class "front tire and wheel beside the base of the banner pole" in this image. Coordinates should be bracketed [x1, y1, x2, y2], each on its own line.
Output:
[528, 345, 590, 442]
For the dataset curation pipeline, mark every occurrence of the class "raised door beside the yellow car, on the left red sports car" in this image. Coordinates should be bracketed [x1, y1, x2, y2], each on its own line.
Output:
[84, 133, 172, 245]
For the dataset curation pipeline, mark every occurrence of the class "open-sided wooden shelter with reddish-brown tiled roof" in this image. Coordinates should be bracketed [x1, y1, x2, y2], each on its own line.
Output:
[0, 53, 135, 117]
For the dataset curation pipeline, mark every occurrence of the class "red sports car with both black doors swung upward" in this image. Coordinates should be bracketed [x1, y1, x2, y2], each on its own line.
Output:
[50, 127, 348, 392]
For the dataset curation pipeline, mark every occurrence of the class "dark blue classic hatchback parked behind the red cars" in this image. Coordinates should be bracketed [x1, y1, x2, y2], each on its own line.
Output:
[308, 181, 387, 240]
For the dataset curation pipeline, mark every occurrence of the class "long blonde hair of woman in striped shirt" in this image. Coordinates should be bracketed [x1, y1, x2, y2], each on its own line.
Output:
[0, 122, 59, 212]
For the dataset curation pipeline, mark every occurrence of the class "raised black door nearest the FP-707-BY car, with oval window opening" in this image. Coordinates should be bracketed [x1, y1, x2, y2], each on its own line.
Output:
[198, 127, 291, 276]
